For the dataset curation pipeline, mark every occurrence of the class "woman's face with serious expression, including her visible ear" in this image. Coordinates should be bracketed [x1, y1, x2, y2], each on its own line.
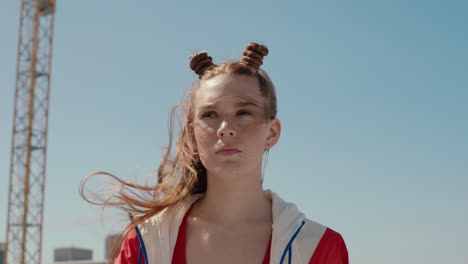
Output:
[194, 74, 281, 177]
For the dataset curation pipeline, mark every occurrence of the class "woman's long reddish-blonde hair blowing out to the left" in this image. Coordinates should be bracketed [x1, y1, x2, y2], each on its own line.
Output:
[80, 44, 277, 263]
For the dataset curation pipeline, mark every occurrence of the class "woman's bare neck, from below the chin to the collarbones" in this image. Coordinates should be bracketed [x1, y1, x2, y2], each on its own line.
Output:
[196, 169, 272, 224]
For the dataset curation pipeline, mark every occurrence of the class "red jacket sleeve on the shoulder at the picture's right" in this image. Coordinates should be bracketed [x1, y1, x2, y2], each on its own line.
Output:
[309, 227, 349, 264]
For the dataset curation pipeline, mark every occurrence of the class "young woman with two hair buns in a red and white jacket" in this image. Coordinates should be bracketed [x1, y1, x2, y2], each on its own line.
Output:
[81, 43, 348, 264]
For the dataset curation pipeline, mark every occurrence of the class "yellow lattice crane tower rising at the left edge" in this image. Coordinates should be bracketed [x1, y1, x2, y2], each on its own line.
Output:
[4, 0, 55, 264]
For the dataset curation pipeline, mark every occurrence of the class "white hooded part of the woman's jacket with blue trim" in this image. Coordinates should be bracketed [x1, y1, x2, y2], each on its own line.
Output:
[132, 190, 327, 264]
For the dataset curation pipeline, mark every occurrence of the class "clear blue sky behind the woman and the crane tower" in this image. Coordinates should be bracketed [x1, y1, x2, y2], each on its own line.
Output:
[0, 0, 468, 264]
